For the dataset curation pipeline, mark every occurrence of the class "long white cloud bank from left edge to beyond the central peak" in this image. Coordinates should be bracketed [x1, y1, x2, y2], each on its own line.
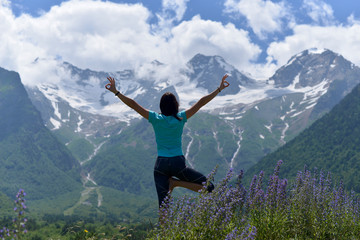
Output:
[0, 0, 261, 85]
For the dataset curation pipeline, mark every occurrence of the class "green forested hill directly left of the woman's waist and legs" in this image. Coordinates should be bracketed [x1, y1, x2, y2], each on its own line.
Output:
[85, 120, 156, 197]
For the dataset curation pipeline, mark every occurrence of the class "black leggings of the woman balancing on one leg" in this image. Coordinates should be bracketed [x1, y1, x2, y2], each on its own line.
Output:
[154, 156, 214, 207]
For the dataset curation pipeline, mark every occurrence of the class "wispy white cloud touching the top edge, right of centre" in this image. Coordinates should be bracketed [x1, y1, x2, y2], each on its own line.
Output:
[225, 0, 292, 38]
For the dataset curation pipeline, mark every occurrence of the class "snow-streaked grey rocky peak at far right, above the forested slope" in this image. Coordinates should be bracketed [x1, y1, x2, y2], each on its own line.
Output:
[268, 49, 360, 120]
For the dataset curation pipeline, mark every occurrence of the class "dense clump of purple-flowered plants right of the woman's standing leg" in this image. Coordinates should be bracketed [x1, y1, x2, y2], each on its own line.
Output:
[148, 161, 360, 240]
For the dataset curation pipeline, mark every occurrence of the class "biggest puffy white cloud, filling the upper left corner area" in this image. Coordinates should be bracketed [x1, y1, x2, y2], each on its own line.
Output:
[0, 0, 162, 83]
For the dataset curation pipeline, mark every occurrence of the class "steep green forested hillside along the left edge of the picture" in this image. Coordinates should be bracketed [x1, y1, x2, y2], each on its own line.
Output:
[0, 68, 81, 202]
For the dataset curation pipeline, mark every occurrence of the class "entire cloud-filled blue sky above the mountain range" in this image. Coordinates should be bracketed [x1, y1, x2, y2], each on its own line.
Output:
[0, 0, 360, 83]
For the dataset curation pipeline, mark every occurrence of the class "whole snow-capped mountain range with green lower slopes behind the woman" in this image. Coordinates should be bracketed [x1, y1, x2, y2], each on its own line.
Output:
[14, 49, 360, 216]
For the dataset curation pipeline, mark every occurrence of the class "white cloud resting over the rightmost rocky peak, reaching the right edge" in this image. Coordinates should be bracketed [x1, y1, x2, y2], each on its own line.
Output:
[267, 23, 360, 69]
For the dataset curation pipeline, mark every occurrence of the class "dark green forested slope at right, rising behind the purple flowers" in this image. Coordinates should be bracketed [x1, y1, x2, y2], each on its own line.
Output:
[245, 85, 360, 192]
